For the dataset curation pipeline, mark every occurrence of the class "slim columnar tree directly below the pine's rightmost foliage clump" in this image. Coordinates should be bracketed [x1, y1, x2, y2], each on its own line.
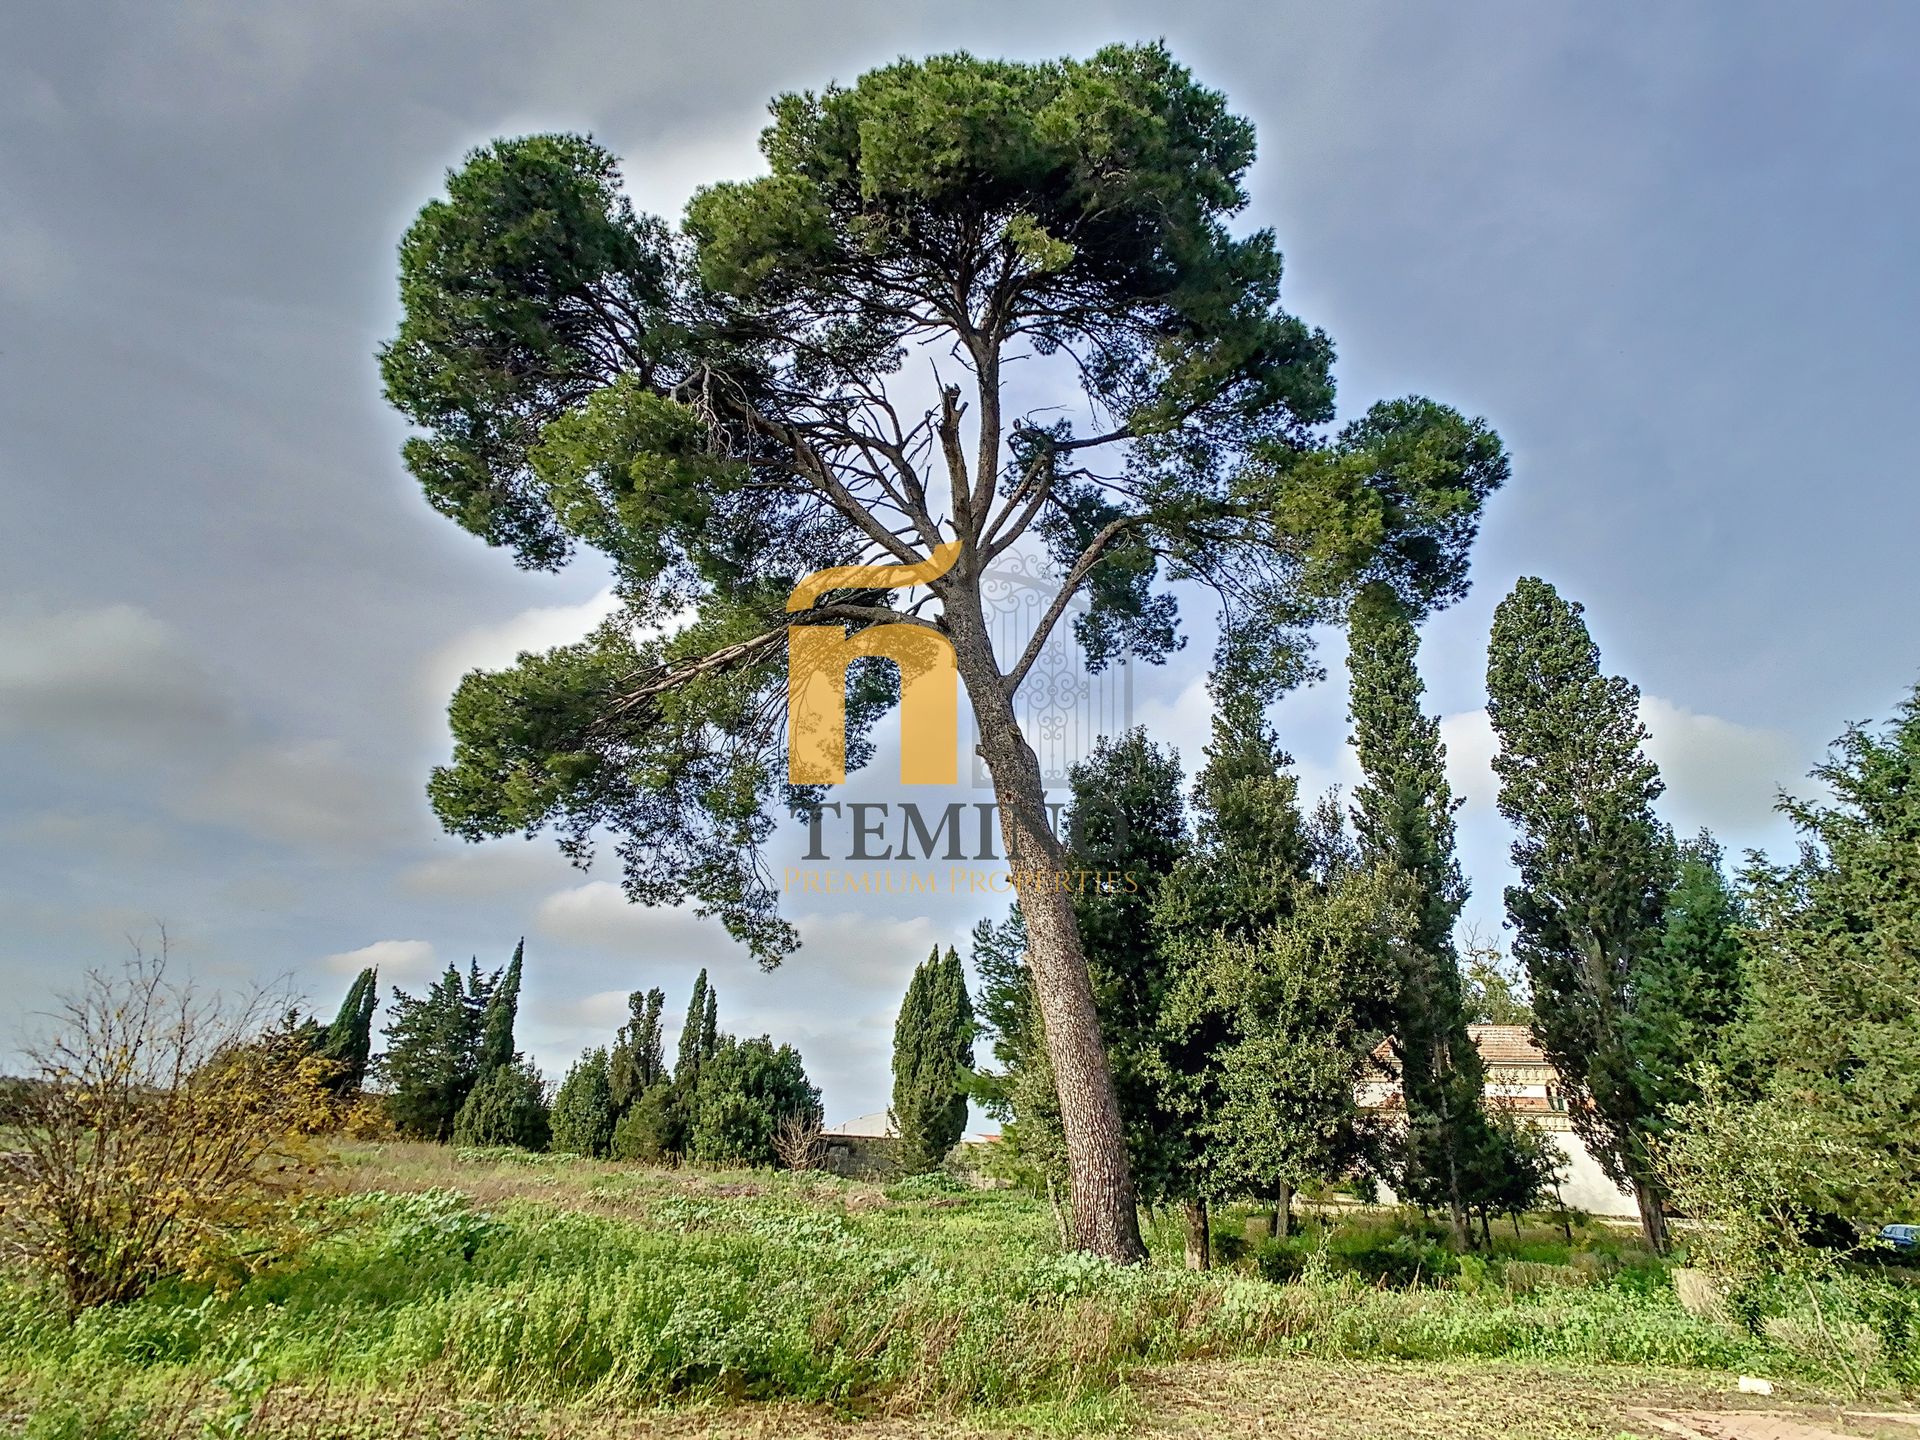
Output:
[1348, 591, 1494, 1248]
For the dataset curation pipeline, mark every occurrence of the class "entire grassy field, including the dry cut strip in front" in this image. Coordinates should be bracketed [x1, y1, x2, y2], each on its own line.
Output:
[0, 1144, 1912, 1438]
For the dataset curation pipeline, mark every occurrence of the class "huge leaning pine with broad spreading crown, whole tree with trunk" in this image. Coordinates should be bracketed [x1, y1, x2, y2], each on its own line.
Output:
[382, 44, 1507, 1260]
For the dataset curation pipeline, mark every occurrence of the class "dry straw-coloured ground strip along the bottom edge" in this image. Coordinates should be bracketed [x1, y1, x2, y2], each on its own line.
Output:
[18, 1359, 1920, 1440]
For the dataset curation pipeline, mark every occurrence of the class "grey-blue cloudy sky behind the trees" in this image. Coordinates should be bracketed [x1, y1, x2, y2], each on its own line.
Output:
[0, 0, 1920, 1119]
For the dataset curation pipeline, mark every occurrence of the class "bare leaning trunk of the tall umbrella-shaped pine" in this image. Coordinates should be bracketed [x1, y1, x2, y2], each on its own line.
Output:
[945, 603, 1146, 1263]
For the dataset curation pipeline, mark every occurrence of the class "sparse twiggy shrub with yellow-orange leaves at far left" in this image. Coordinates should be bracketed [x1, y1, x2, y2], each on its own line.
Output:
[0, 948, 332, 1313]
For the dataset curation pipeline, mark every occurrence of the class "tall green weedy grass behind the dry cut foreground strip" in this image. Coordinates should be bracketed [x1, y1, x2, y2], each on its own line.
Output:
[0, 1146, 1905, 1434]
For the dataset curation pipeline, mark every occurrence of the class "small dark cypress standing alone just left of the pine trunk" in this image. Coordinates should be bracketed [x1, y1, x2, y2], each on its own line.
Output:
[893, 945, 973, 1175]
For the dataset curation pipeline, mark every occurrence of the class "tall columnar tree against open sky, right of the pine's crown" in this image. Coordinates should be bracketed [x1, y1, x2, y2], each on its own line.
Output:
[1486, 576, 1672, 1250]
